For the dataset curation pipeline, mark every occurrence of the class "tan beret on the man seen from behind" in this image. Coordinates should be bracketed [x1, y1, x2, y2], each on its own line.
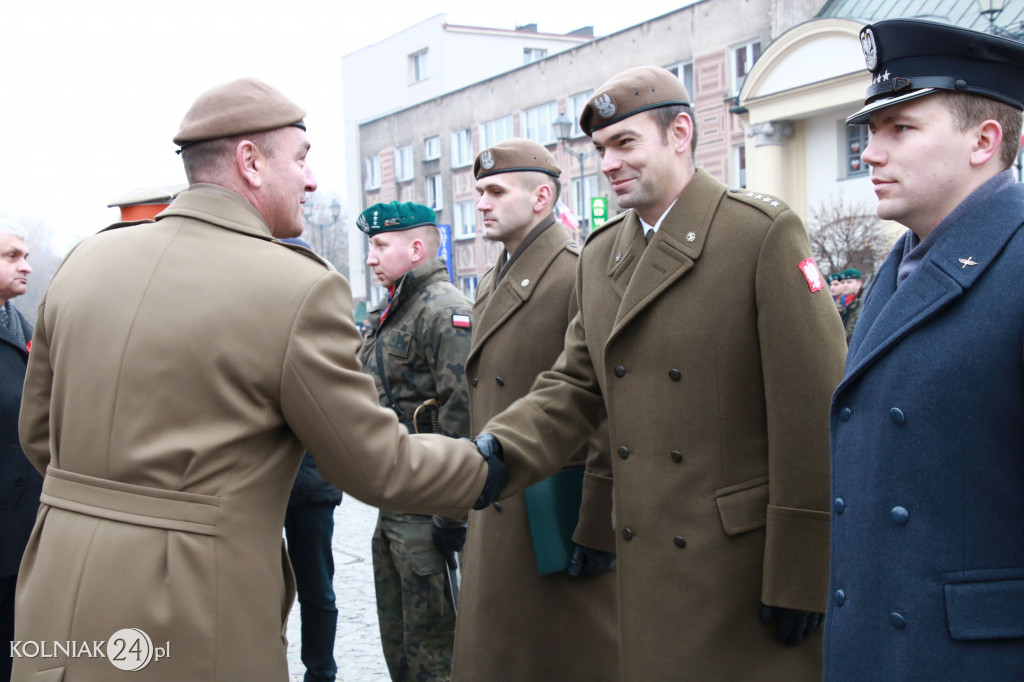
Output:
[174, 78, 306, 148]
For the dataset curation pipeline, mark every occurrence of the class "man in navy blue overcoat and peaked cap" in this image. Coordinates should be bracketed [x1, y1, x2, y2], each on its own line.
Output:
[824, 19, 1024, 682]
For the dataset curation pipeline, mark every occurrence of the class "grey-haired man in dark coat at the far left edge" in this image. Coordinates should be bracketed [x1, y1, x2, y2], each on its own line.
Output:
[0, 220, 36, 680]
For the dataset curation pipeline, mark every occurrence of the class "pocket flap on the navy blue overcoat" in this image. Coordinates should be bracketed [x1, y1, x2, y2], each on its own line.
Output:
[945, 579, 1024, 639]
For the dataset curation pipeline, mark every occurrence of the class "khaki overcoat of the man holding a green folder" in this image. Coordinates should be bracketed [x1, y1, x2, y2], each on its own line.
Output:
[452, 217, 618, 682]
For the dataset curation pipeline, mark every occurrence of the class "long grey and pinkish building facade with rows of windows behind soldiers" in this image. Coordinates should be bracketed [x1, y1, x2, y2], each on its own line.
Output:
[350, 0, 822, 300]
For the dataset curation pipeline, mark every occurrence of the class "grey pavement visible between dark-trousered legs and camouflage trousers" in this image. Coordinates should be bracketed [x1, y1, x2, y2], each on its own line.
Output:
[288, 495, 391, 682]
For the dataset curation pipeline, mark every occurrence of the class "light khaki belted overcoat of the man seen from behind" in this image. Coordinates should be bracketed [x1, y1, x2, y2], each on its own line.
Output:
[14, 184, 486, 682]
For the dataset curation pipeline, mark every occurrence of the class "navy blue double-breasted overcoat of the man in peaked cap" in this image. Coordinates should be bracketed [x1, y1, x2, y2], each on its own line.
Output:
[824, 178, 1024, 682]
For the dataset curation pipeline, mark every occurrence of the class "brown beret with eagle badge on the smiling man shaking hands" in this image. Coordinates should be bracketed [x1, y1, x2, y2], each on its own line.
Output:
[580, 67, 690, 135]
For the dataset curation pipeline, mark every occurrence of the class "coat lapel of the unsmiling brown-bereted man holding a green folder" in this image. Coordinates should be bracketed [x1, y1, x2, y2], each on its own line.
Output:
[467, 223, 569, 364]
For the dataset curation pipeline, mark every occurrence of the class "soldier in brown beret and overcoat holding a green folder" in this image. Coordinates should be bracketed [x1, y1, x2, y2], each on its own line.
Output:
[453, 139, 618, 682]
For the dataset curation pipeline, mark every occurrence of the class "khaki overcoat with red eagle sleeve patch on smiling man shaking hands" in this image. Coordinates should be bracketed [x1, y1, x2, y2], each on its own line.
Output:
[483, 170, 846, 682]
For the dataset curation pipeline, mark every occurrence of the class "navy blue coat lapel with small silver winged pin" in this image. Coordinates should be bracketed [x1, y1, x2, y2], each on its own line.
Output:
[840, 184, 1024, 389]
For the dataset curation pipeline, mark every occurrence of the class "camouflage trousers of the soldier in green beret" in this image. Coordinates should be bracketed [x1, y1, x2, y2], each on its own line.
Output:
[372, 511, 455, 682]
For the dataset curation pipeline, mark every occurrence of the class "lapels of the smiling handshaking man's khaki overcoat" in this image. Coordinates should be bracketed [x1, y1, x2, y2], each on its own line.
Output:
[608, 170, 725, 340]
